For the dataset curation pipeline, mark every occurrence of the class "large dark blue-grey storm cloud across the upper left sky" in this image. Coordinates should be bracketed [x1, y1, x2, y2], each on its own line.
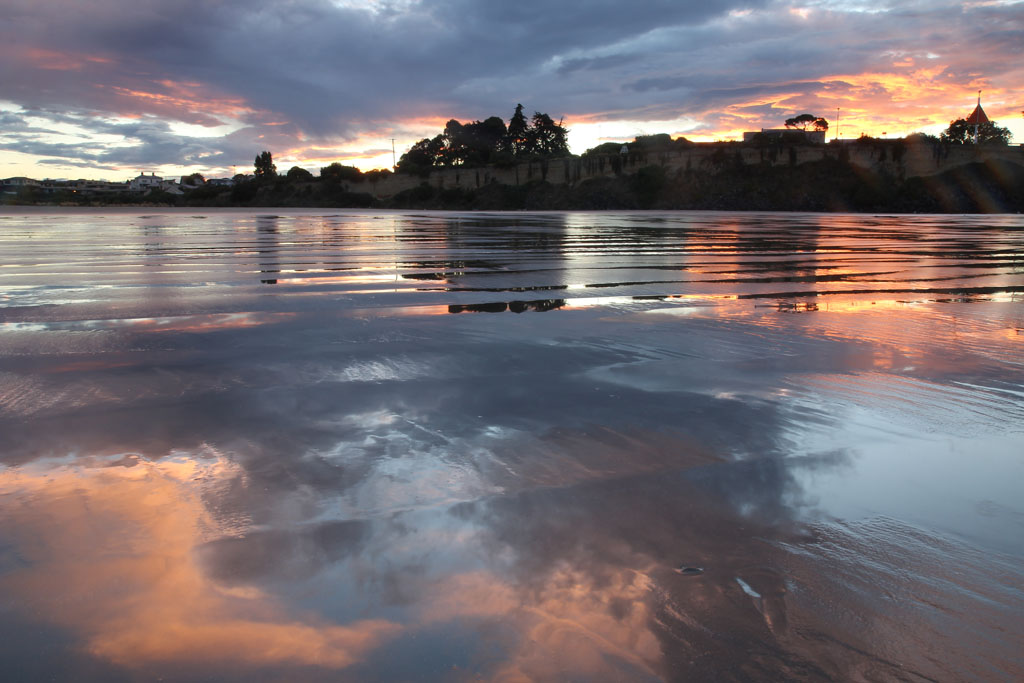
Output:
[4, 0, 760, 132]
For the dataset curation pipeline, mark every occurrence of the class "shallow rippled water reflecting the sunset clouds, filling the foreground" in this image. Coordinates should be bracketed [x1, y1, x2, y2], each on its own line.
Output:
[0, 209, 1024, 681]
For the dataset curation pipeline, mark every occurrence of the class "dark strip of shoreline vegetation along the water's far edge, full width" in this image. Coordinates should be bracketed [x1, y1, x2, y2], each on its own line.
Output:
[3, 158, 1024, 215]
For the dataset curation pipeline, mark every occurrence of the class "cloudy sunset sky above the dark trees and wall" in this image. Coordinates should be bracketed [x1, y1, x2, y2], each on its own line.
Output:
[0, 0, 1024, 180]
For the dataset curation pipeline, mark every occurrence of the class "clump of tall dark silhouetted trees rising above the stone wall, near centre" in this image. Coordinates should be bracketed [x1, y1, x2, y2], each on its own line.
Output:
[397, 104, 569, 175]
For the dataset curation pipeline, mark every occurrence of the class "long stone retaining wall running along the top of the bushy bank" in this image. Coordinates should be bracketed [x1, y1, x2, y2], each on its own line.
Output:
[348, 140, 1024, 199]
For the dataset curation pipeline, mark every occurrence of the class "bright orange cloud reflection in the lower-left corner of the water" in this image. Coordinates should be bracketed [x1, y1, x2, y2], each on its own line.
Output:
[0, 460, 401, 672]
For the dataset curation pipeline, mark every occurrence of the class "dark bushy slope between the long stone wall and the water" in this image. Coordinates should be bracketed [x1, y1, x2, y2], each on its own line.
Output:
[384, 155, 1024, 213]
